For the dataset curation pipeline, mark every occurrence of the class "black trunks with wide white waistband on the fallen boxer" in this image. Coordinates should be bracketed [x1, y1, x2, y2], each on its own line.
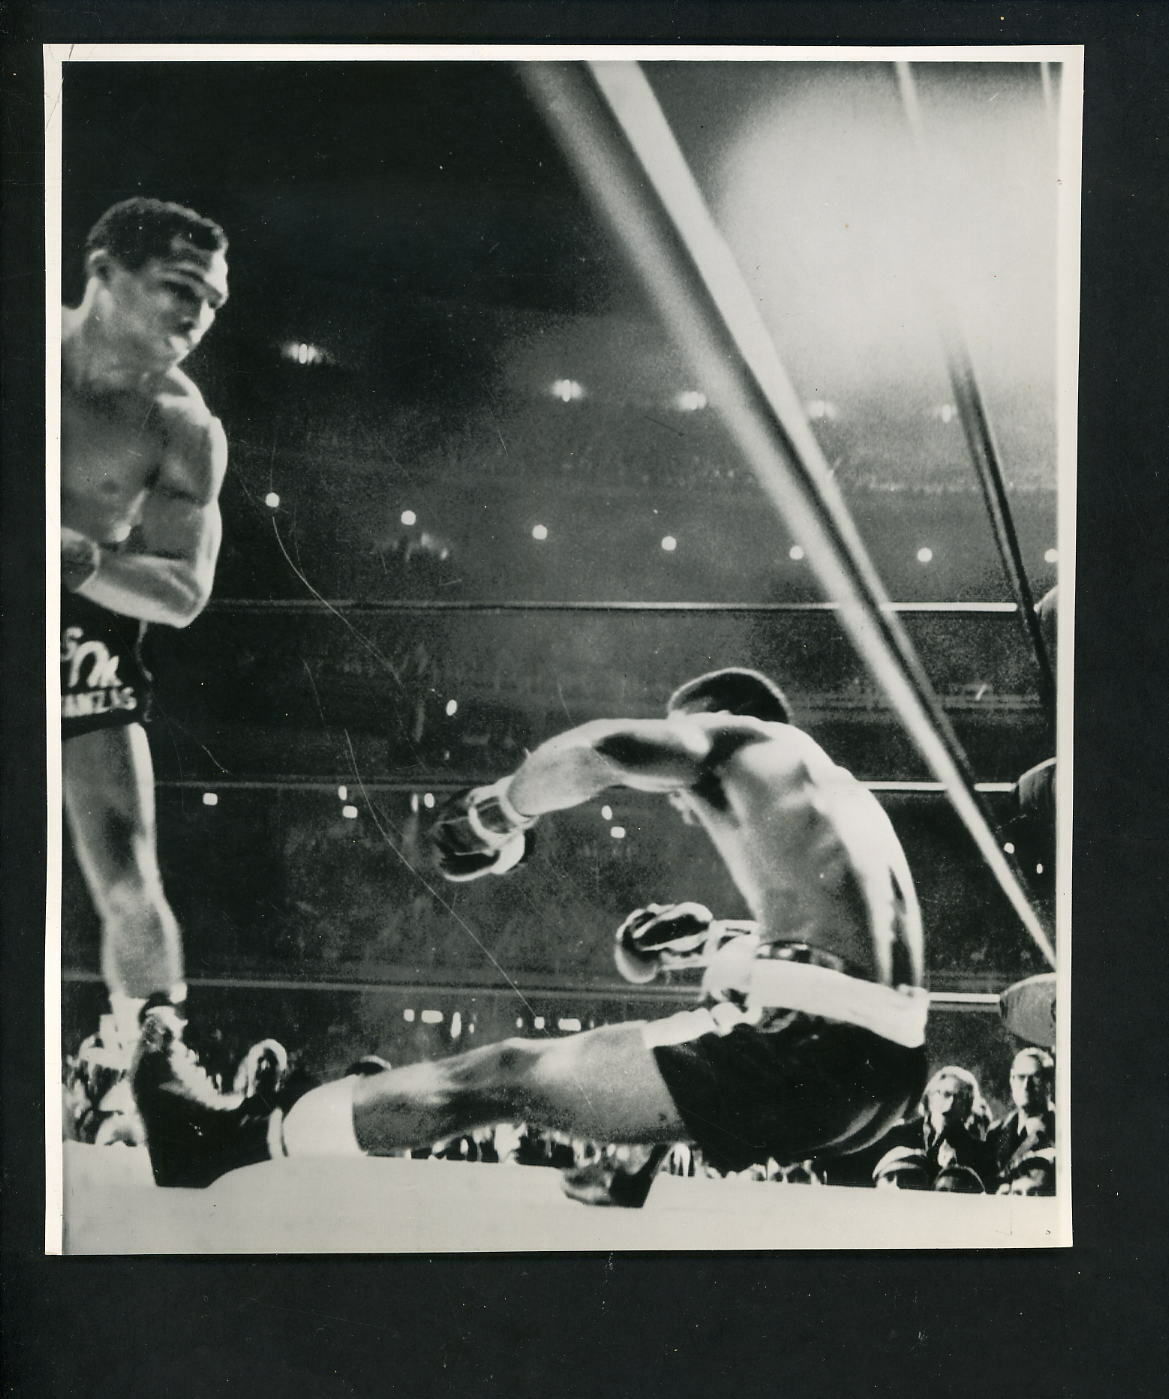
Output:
[645, 949, 927, 1171]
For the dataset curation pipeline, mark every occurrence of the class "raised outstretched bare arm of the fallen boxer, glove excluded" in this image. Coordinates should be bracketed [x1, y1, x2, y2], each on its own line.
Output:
[508, 718, 710, 816]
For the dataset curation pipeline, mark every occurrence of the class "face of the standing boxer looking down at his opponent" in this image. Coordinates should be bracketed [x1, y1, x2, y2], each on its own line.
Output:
[91, 236, 228, 365]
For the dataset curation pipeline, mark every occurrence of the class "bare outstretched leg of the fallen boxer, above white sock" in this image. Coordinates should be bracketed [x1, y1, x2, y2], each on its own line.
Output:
[354, 1021, 689, 1154]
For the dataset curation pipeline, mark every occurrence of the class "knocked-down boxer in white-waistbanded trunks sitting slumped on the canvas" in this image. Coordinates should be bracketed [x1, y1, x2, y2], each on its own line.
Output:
[134, 670, 928, 1205]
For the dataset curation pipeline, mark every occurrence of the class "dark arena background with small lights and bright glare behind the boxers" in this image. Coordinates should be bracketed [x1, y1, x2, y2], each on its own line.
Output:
[62, 51, 1060, 1247]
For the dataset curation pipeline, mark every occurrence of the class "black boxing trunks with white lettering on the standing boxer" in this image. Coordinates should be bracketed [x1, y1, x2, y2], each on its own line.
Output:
[62, 592, 151, 739]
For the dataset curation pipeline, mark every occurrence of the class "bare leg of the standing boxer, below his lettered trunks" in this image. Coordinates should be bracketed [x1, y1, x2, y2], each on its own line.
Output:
[62, 723, 183, 997]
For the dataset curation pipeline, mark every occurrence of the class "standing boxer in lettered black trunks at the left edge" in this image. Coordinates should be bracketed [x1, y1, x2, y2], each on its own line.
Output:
[60, 199, 228, 1067]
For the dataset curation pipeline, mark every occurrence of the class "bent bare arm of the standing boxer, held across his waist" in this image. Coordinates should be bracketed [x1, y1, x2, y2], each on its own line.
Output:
[77, 414, 228, 627]
